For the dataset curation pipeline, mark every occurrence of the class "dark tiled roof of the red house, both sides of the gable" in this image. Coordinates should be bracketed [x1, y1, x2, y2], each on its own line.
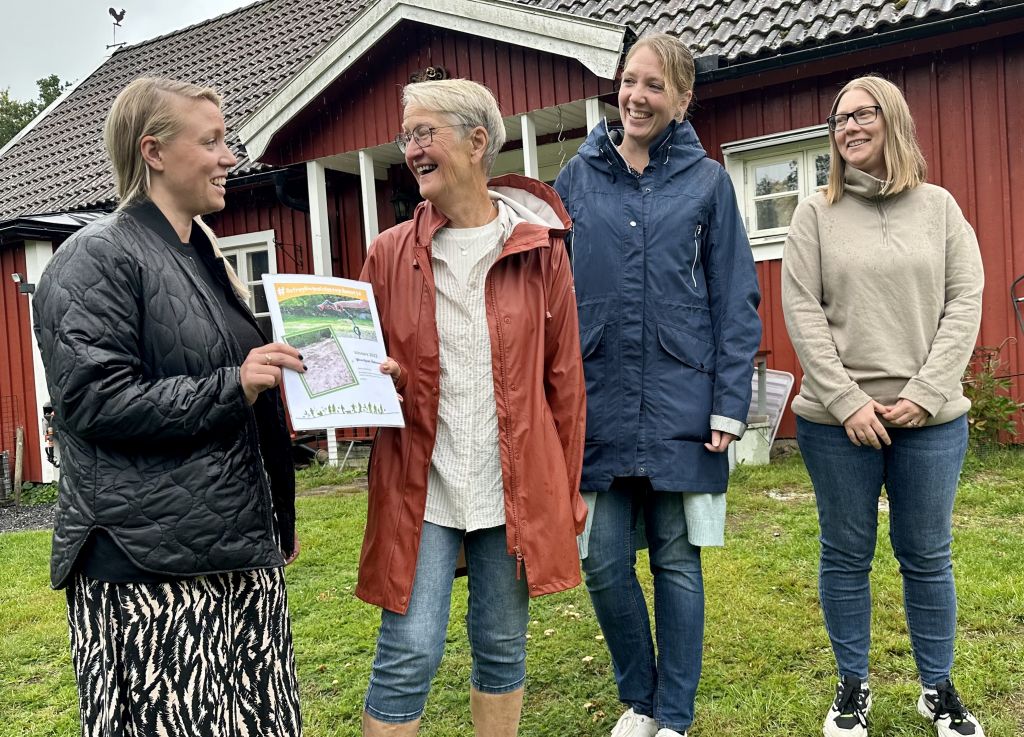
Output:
[0, 0, 1007, 222]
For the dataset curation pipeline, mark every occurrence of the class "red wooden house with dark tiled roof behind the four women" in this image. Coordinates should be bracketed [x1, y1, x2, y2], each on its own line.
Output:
[0, 0, 1024, 479]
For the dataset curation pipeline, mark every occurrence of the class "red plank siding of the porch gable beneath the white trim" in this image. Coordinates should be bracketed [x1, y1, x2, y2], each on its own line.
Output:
[262, 23, 613, 165]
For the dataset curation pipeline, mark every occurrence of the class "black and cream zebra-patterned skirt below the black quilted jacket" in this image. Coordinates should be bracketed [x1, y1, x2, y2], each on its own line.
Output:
[68, 568, 302, 737]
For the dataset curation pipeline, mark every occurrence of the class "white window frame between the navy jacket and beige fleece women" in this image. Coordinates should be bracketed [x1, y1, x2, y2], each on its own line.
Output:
[722, 124, 828, 261]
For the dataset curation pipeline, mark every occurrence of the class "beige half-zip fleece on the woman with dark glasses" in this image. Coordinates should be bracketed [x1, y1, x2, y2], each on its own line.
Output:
[782, 166, 984, 425]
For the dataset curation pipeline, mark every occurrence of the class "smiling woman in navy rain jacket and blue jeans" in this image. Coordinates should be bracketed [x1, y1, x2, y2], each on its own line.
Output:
[555, 34, 761, 737]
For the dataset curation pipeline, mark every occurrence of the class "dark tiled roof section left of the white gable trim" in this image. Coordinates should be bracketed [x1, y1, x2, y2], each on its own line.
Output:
[0, 0, 366, 221]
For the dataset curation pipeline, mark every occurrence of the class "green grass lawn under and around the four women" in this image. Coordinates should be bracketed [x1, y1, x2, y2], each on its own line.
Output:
[0, 451, 1024, 737]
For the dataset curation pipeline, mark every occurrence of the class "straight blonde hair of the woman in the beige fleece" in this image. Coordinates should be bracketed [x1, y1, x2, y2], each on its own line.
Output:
[825, 75, 928, 205]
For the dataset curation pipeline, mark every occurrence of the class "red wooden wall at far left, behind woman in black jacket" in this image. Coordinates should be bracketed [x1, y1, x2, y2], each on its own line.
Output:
[0, 244, 43, 481]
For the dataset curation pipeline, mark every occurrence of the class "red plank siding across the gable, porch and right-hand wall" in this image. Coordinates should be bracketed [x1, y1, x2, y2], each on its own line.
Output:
[218, 26, 1024, 444]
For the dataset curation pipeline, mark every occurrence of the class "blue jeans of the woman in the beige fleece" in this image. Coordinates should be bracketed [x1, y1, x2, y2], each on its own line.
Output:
[797, 417, 968, 686]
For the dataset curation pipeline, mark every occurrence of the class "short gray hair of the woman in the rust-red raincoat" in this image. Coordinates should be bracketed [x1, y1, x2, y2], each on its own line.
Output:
[401, 79, 505, 176]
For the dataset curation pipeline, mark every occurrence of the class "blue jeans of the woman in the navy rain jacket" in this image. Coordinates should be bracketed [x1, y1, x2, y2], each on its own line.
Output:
[583, 478, 705, 733]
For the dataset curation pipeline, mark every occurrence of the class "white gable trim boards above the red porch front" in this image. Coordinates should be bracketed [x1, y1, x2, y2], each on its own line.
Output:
[239, 0, 627, 161]
